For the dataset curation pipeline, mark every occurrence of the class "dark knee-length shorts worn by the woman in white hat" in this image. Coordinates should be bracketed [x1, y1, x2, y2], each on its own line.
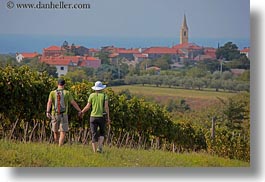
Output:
[90, 116, 106, 143]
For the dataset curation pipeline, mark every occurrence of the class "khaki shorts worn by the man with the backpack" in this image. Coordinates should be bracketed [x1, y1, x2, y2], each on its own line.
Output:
[52, 114, 69, 132]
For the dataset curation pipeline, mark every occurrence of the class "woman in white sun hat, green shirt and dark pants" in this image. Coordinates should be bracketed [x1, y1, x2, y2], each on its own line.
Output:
[81, 81, 110, 153]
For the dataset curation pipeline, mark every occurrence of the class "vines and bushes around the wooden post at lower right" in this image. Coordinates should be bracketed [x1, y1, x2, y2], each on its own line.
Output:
[179, 93, 250, 161]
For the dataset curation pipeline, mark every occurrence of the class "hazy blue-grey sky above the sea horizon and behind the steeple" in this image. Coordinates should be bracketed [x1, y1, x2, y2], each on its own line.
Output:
[0, 0, 250, 38]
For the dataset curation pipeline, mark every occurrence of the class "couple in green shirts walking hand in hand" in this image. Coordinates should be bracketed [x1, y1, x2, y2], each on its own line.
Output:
[46, 79, 110, 152]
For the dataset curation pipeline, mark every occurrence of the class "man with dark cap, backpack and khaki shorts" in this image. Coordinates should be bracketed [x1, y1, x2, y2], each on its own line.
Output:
[46, 79, 81, 146]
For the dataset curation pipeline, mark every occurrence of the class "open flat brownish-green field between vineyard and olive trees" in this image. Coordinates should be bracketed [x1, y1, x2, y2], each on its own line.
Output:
[111, 85, 236, 110]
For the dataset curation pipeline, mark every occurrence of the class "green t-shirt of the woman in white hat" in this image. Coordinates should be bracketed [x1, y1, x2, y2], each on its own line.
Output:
[88, 93, 108, 117]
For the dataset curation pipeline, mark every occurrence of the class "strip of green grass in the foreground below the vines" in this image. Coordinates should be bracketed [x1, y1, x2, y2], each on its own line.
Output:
[0, 140, 250, 167]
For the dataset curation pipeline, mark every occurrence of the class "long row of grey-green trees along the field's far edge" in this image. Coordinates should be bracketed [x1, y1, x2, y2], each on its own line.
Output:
[124, 73, 249, 91]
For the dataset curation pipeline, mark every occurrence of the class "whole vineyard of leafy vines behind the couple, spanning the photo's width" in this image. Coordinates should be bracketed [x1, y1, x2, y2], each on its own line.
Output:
[0, 66, 250, 161]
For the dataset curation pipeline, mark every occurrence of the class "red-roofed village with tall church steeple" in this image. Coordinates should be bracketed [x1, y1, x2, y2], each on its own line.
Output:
[13, 15, 250, 77]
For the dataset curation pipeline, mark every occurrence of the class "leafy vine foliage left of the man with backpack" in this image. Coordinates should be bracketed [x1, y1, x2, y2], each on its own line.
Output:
[0, 66, 55, 120]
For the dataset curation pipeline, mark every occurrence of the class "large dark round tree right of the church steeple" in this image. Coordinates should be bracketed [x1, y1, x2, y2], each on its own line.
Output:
[216, 42, 240, 61]
